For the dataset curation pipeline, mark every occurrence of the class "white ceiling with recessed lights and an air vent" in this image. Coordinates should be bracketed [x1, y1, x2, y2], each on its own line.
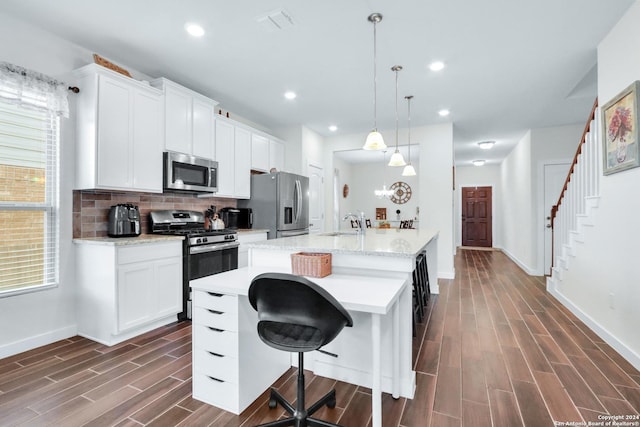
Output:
[0, 0, 634, 164]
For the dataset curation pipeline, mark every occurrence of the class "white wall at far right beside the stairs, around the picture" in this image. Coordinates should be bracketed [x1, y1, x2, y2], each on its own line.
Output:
[557, 2, 640, 369]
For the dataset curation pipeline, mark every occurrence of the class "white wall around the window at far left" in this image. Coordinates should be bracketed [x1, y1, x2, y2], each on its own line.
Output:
[0, 10, 93, 358]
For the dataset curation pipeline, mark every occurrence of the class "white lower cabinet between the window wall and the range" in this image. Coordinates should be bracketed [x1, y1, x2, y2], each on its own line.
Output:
[77, 241, 182, 345]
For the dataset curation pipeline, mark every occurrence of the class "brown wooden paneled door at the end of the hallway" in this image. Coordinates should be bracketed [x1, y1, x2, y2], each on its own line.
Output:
[462, 187, 493, 248]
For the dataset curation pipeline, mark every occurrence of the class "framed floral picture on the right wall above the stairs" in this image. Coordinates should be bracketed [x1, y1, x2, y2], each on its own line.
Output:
[602, 81, 640, 175]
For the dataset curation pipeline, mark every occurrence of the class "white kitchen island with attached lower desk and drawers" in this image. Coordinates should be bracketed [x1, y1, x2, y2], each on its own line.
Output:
[191, 229, 438, 427]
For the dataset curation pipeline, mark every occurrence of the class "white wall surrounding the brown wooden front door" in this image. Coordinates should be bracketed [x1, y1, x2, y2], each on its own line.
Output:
[454, 164, 502, 248]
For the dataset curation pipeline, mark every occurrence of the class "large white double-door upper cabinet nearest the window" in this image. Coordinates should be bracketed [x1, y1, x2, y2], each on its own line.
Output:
[73, 64, 163, 193]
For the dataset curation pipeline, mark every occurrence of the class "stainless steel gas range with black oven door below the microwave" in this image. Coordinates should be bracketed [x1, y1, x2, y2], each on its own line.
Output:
[150, 210, 240, 320]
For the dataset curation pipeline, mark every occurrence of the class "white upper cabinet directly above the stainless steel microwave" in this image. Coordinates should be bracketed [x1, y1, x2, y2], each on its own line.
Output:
[151, 78, 218, 160]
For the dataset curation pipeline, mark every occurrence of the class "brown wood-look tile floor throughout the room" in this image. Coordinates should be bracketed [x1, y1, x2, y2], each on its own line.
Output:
[0, 250, 640, 427]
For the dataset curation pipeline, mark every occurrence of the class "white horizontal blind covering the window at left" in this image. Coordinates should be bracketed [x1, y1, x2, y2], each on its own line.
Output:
[0, 101, 60, 297]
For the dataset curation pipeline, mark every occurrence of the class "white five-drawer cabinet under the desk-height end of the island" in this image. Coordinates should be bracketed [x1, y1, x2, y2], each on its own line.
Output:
[192, 290, 290, 414]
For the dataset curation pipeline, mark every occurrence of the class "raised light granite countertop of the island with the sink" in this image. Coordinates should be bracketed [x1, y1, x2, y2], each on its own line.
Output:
[247, 228, 438, 257]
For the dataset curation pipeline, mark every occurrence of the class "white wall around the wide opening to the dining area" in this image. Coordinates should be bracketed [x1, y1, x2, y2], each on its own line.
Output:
[324, 123, 455, 278]
